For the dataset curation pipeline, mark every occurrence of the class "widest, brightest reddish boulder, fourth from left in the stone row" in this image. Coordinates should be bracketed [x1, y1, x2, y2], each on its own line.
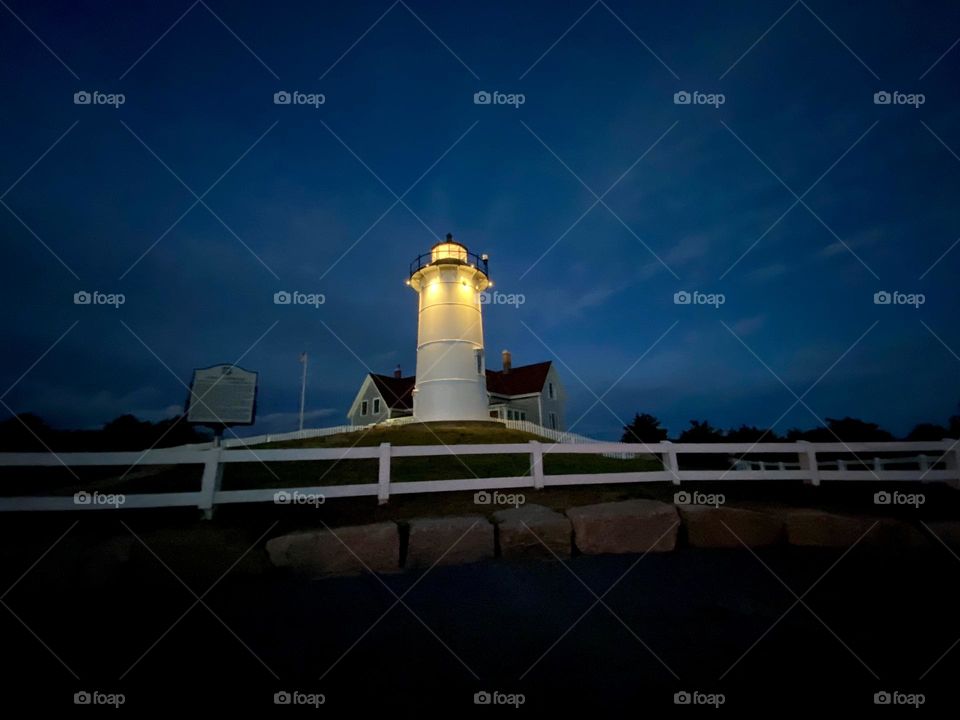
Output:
[567, 500, 680, 555]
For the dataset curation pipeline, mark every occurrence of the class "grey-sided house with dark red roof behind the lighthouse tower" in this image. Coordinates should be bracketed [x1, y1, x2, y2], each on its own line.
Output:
[347, 350, 566, 430]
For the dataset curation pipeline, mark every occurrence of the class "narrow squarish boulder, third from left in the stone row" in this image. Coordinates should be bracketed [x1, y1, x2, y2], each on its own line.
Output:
[493, 505, 571, 560]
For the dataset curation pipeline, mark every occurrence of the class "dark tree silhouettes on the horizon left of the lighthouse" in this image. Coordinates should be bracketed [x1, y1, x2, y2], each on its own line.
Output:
[0, 413, 210, 452]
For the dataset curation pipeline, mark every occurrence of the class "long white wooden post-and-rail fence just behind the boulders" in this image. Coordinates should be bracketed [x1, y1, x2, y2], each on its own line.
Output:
[0, 440, 960, 515]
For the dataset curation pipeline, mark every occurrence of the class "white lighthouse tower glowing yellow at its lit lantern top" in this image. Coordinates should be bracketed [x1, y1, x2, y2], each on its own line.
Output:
[407, 234, 493, 421]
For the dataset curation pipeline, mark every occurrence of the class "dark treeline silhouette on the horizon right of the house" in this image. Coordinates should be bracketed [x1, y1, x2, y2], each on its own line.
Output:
[620, 413, 960, 443]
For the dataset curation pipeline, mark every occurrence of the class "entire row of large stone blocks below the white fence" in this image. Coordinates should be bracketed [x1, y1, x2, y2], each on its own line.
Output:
[258, 500, 960, 577]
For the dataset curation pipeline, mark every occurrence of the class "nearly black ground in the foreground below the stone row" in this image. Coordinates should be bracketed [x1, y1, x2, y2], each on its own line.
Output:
[0, 518, 960, 717]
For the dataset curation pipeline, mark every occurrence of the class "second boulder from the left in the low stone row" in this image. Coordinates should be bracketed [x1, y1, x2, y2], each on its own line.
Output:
[406, 515, 494, 568]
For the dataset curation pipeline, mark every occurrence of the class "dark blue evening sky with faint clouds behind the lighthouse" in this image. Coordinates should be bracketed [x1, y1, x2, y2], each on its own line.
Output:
[0, 0, 960, 437]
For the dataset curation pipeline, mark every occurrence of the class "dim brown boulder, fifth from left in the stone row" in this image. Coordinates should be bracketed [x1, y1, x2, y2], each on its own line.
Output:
[677, 505, 783, 548]
